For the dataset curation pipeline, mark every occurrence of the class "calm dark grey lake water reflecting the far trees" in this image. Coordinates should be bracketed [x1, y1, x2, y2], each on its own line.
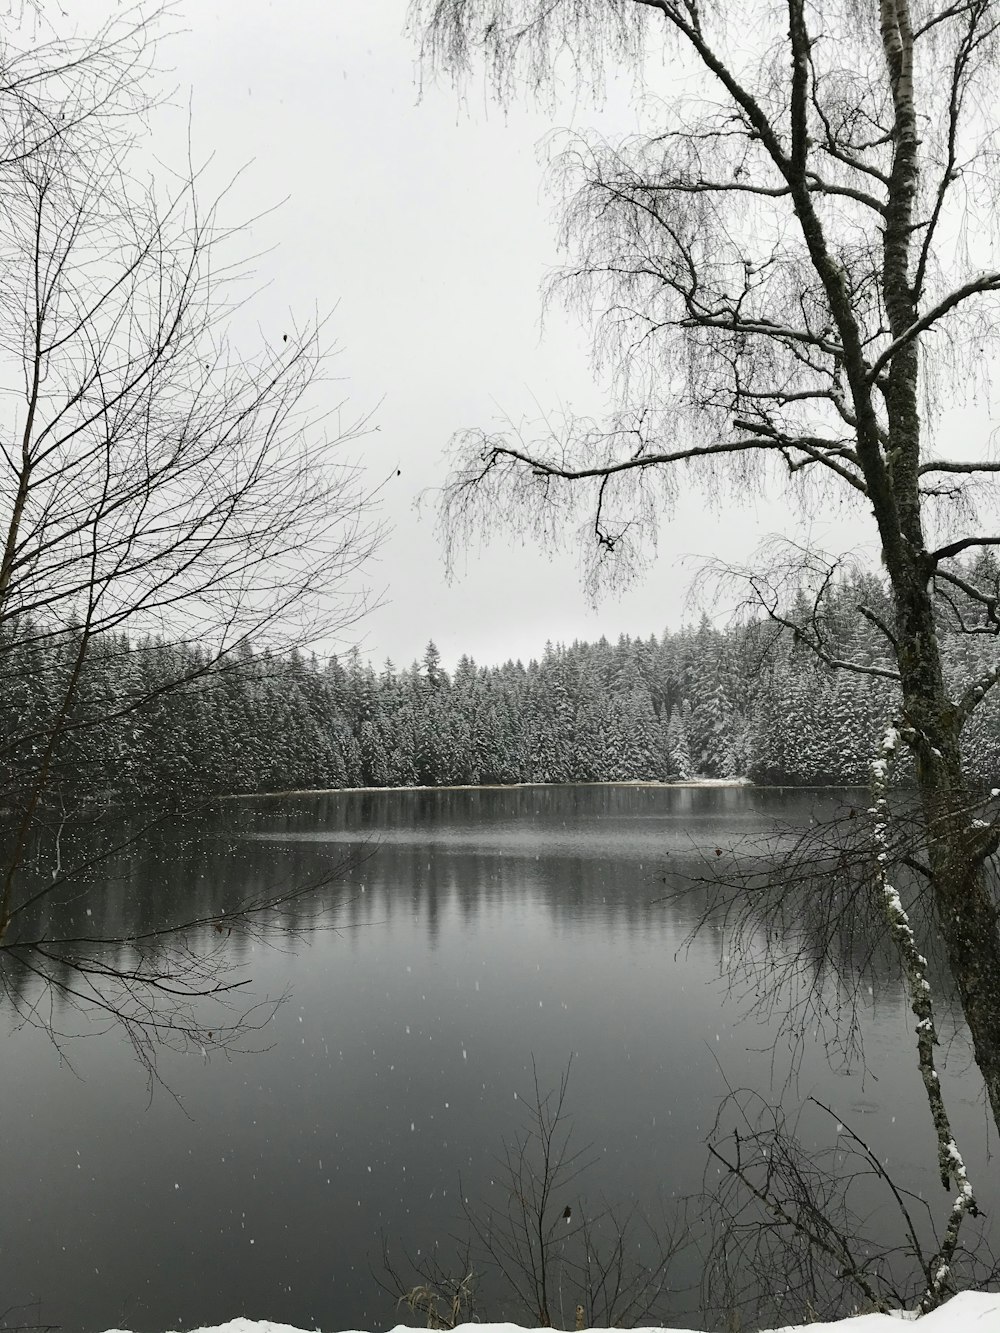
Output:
[0, 788, 984, 1330]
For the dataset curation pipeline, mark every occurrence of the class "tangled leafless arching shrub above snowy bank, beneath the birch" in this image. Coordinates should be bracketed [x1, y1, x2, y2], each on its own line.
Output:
[701, 1089, 997, 1322]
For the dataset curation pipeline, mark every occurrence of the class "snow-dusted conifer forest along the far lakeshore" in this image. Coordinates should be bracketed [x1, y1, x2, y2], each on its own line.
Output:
[0, 562, 1000, 801]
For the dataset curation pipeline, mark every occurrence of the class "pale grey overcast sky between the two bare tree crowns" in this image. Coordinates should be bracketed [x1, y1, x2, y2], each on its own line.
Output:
[155, 0, 869, 665]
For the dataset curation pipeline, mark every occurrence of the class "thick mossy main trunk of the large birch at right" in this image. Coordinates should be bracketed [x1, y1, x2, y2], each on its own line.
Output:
[865, 0, 1000, 1129]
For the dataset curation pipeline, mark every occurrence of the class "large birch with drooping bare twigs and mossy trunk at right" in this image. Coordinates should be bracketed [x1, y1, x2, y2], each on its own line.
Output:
[411, 0, 1000, 1125]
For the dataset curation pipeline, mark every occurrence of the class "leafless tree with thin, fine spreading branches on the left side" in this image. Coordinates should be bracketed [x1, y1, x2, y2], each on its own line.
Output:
[0, 8, 377, 1057]
